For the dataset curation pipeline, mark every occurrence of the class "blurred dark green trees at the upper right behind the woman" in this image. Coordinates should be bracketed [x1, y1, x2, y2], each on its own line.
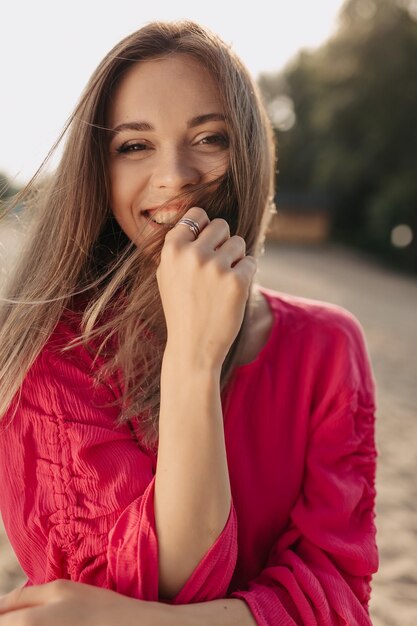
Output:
[260, 0, 417, 270]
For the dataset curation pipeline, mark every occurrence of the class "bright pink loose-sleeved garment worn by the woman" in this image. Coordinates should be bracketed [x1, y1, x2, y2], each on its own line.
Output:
[0, 289, 378, 626]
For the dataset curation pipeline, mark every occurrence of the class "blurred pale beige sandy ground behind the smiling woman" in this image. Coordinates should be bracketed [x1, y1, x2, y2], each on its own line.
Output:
[0, 217, 417, 626]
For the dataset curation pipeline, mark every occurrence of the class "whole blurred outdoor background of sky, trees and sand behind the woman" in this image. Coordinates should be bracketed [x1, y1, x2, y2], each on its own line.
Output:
[0, 0, 417, 626]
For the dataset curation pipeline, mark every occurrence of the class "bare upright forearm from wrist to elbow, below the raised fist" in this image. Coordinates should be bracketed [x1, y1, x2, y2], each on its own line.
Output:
[155, 349, 231, 598]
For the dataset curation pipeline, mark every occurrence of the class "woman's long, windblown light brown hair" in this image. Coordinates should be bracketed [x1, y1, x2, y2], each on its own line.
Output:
[0, 21, 275, 445]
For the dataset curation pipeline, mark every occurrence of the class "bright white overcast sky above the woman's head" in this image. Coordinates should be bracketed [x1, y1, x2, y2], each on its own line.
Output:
[0, 0, 343, 184]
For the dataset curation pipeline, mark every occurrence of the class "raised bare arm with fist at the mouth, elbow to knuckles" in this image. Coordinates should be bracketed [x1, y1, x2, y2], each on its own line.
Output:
[155, 207, 256, 598]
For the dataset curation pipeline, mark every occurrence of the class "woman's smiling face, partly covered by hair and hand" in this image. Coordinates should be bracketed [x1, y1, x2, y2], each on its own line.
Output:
[108, 54, 229, 245]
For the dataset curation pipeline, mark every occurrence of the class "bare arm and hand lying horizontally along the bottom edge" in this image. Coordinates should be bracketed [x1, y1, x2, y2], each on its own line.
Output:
[0, 580, 256, 626]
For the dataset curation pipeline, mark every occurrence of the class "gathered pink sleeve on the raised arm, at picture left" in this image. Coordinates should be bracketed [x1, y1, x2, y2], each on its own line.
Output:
[0, 334, 237, 602]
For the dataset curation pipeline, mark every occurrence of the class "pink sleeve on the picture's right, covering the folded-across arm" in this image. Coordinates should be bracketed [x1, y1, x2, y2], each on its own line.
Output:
[232, 310, 378, 626]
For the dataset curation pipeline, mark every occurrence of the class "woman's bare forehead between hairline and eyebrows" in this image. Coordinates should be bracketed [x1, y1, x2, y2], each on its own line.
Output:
[108, 53, 224, 125]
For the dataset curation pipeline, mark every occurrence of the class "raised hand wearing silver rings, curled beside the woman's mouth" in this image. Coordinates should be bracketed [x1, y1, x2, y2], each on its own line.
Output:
[156, 207, 257, 368]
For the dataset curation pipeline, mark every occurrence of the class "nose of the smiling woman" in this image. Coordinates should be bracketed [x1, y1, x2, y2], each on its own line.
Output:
[152, 147, 201, 191]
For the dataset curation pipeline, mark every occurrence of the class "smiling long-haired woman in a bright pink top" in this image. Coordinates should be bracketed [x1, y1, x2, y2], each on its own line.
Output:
[0, 22, 377, 625]
